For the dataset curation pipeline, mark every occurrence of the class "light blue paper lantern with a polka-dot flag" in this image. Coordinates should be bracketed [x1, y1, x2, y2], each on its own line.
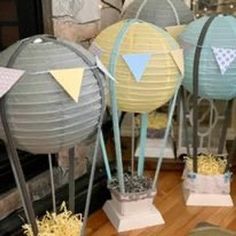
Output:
[180, 15, 236, 100]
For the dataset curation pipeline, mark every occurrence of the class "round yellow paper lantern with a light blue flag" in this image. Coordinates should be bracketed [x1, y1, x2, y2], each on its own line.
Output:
[90, 20, 183, 113]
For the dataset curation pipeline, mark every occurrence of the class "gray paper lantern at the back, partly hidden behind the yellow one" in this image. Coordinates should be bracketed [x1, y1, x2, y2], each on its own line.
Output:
[122, 0, 193, 28]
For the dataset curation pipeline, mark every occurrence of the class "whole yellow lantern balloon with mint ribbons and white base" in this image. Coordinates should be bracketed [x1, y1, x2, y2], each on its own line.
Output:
[90, 20, 183, 232]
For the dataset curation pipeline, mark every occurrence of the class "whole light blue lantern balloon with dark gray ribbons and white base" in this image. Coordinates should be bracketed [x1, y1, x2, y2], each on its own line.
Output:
[180, 14, 236, 206]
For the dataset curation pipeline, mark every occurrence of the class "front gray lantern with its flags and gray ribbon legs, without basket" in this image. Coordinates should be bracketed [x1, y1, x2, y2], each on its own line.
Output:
[0, 35, 105, 235]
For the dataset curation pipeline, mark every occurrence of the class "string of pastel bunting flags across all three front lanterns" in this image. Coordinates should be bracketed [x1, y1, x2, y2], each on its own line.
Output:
[0, 44, 236, 102]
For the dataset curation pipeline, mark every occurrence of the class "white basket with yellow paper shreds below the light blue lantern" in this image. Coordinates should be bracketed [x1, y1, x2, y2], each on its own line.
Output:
[183, 154, 233, 206]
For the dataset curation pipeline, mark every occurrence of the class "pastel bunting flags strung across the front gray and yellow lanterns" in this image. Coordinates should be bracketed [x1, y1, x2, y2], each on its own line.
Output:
[0, 49, 184, 102]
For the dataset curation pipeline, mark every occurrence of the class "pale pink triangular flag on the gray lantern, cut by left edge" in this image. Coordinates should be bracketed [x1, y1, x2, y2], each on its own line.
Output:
[0, 67, 25, 98]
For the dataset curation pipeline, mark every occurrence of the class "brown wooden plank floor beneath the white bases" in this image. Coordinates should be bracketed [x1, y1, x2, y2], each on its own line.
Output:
[87, 171, 236, 236]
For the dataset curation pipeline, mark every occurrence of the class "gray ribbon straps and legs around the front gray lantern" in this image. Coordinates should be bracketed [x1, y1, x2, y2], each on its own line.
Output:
[0, 35, 105, 236]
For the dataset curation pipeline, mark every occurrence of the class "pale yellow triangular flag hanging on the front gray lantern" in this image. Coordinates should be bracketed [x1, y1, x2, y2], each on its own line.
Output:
[50, 68, 84, 102]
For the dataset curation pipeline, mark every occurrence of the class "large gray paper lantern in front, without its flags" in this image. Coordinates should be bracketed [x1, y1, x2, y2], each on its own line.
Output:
[0, 36, 104, 153]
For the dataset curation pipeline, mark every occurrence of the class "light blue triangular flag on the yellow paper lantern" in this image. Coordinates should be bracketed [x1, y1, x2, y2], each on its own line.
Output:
[123, 53, 151, 81]
